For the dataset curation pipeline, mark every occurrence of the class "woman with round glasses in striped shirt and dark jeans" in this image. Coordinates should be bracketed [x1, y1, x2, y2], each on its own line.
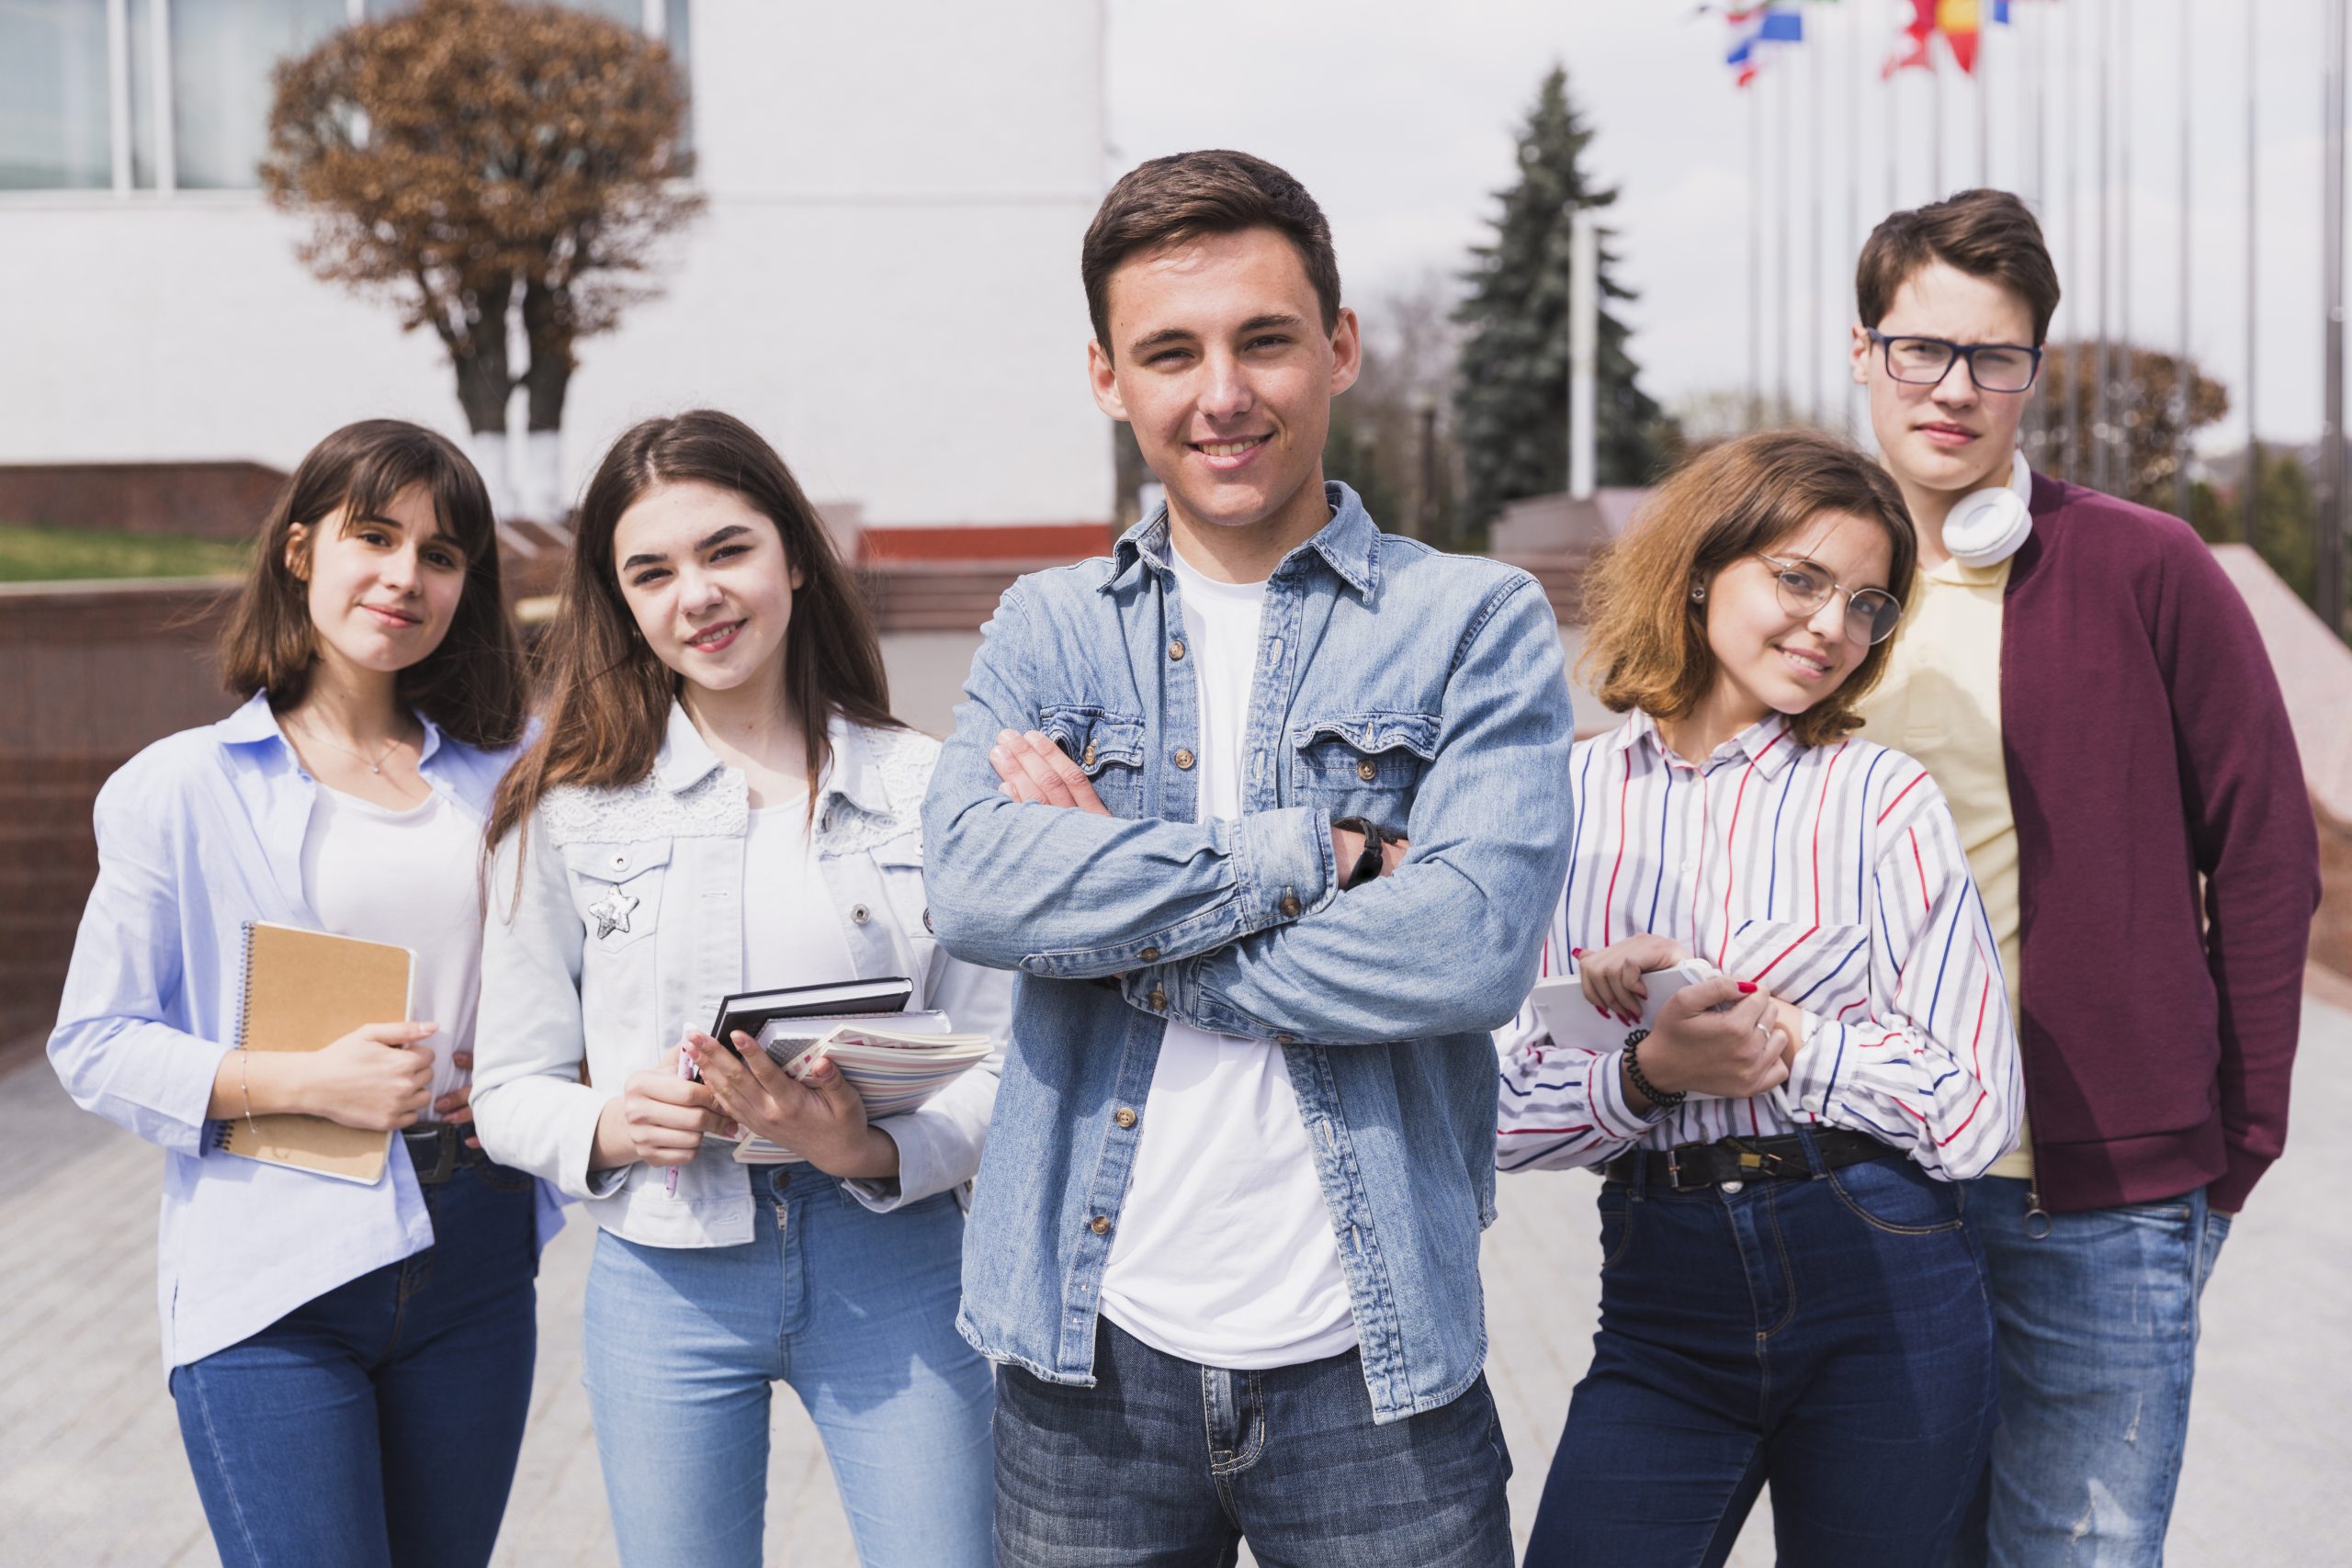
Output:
[1496, 433, 2020, 1568]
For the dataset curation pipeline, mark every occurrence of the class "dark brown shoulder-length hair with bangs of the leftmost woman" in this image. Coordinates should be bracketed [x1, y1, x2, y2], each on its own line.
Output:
[217, 419, 526, 748]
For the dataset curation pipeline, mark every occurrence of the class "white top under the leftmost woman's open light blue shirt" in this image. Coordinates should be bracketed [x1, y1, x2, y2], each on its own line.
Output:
[301, 785, 482, 1122]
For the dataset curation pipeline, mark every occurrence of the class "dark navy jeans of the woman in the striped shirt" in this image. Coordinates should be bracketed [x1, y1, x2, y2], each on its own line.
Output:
[1526, 1156, 1995, 1568]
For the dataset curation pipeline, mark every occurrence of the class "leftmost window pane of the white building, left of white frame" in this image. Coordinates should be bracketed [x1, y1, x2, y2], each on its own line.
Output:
[0, 0, 115, 190]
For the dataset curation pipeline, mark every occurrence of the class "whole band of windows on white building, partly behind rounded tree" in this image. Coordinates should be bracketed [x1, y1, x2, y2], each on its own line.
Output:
[0, 0, 689, 190]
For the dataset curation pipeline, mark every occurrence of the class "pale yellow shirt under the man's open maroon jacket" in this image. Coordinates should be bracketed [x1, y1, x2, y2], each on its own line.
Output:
[1863, 559, 2034, 1178]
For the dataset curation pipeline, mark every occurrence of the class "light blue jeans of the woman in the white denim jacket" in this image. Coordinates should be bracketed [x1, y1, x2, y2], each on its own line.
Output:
[583, 1164, 992, 1568]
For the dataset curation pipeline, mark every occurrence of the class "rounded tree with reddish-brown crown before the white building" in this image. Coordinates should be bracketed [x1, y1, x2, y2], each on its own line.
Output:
[261, 0, 701, 517]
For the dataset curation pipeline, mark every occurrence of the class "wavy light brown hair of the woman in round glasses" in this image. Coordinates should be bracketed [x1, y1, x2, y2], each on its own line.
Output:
[1578, 430, 1919, 745]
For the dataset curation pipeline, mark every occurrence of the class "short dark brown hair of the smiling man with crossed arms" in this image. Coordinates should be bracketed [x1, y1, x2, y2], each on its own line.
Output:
[1077, 151, 1339, 353]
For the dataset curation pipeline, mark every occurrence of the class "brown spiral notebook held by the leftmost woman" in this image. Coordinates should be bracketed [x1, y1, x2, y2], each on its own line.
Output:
[217, 919, 416, 1185]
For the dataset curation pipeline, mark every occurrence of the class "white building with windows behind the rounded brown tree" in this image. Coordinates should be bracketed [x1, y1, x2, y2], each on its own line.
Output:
[0, 0, 1113, 552]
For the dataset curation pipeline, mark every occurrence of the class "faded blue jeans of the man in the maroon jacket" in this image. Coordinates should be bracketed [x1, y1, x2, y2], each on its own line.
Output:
[1952, 1176, 2230, 1568]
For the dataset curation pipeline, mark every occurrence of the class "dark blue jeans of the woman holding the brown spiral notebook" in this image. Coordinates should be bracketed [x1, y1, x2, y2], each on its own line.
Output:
[172, 1161, 538, 1568]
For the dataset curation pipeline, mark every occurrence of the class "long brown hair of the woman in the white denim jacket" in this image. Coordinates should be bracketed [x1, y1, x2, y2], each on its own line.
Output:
[487, 409, 899, 846]
